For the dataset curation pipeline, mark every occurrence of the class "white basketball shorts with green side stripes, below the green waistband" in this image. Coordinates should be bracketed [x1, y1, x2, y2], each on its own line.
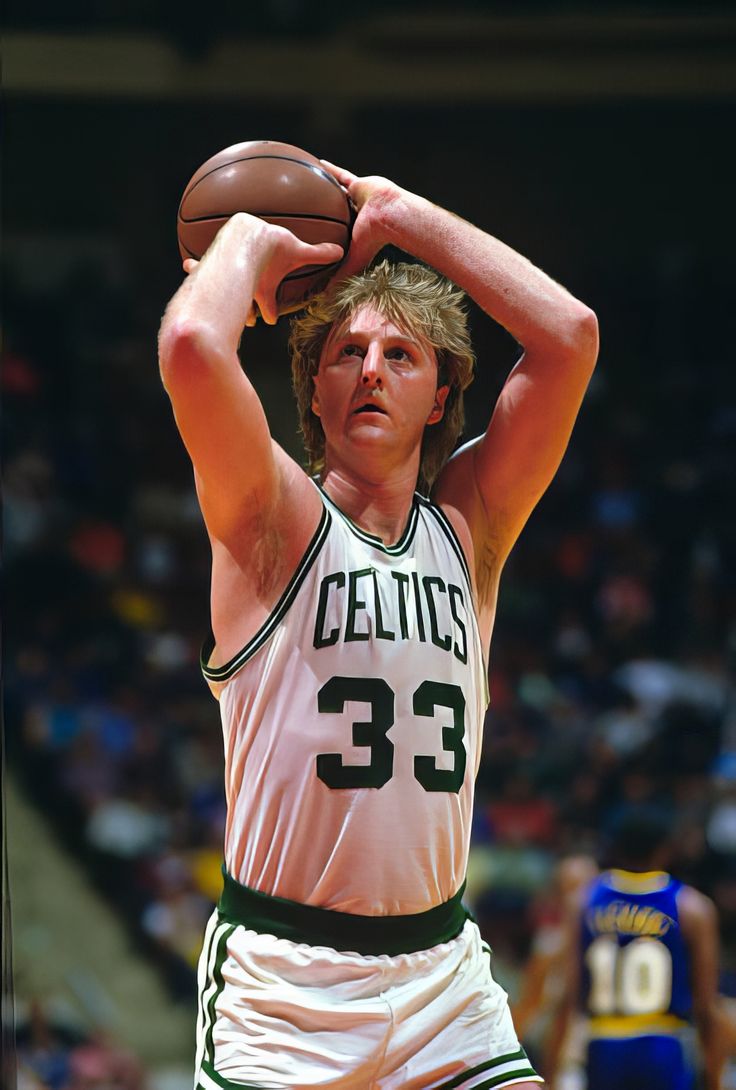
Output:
[195, 911, 542, 1090]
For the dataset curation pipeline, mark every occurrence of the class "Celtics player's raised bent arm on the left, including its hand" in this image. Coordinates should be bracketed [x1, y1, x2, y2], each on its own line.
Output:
[159, 213, 341, 547]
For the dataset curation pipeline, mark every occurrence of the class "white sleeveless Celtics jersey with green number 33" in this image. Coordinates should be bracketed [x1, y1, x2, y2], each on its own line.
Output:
[203, 493, 487, 916]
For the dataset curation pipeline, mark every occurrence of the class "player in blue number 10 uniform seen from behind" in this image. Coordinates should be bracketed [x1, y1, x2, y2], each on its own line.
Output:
[550, 807, 725, 1090]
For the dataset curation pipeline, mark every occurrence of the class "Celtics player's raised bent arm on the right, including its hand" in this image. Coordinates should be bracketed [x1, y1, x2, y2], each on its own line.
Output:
[322, 168, 598, 619]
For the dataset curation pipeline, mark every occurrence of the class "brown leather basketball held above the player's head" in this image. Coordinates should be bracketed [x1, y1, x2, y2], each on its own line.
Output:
[177, 140, 354, 314]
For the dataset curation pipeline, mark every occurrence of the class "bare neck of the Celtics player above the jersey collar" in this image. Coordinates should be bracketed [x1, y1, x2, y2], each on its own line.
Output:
[321, 467, 417, 545]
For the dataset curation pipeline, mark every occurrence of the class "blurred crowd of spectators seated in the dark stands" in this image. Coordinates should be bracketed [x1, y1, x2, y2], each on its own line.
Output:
[2, 225, 736, 1076]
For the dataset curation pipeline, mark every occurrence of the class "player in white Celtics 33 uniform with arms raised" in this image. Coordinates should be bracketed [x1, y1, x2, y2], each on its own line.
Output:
[160, 158, 598, 1090]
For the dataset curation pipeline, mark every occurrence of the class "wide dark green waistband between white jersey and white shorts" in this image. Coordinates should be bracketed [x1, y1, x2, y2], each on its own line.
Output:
[217, 868, 468, 956]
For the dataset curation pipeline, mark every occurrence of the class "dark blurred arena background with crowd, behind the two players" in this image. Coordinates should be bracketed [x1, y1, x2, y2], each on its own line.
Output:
[2, 6, 736, 1090]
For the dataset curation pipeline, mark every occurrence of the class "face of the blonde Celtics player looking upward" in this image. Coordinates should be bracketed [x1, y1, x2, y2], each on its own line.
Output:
[312, 306, 449, 475]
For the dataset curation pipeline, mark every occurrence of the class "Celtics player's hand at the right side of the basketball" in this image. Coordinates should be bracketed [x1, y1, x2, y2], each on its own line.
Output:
[319, 159, 403, 282]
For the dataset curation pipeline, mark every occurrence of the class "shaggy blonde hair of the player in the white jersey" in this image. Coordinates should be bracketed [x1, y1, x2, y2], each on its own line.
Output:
[289, 261, 475, 492]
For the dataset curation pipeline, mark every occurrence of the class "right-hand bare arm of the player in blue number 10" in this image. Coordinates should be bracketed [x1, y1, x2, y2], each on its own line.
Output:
[677, 886, 725, 1090]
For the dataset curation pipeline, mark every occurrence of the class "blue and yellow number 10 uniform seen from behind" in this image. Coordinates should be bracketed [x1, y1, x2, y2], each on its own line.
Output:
[581, 870, 696, 1090]
